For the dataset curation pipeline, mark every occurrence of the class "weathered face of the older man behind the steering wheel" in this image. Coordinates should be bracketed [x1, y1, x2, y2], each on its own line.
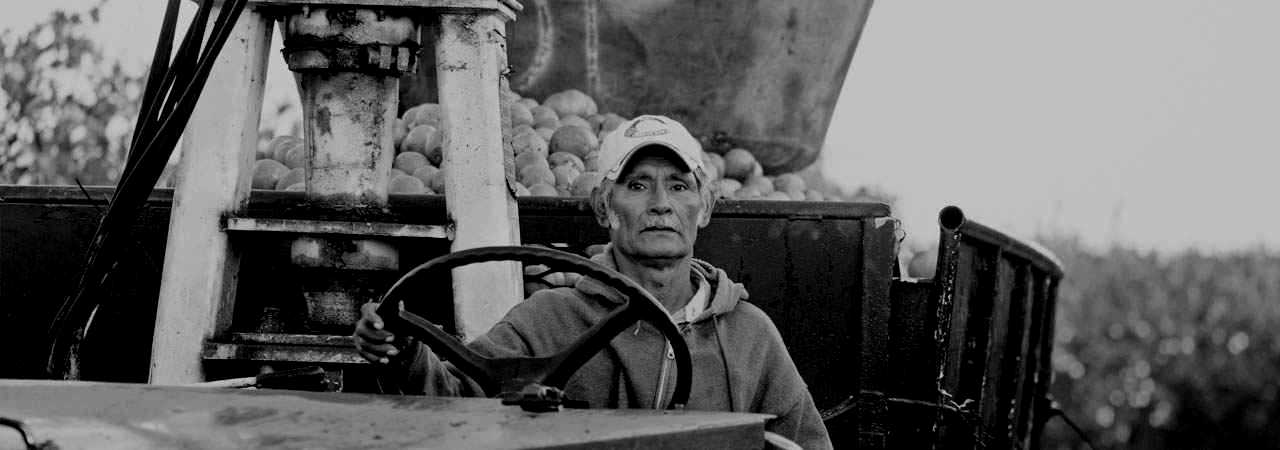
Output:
[607, 151, 708, 260]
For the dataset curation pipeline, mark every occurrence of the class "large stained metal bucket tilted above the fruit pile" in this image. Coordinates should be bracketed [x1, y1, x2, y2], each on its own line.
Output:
[402, 0, 872, 174]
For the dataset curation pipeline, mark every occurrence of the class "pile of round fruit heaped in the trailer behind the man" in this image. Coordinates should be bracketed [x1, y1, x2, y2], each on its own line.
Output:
[253, 89, 837, 201]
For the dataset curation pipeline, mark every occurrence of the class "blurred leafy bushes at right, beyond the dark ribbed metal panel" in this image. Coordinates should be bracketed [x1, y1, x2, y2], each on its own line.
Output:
[1044, 239, 1280, 449]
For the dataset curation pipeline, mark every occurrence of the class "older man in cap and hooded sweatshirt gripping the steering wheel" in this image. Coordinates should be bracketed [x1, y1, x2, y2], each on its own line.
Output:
[356, 115, 831, 449]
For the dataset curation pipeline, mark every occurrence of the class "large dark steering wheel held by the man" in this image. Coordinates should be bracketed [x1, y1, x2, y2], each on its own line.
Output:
[378, 245, 692, 409]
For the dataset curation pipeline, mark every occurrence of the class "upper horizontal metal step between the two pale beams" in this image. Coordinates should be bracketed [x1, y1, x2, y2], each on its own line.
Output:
[223, 217, 453, 240]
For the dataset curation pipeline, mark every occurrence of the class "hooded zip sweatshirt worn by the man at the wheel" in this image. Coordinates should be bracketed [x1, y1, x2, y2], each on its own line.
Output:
[406, 248, 831, 449]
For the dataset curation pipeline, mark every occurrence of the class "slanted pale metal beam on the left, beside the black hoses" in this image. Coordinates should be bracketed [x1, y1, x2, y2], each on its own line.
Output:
[151, 6, 271, 384]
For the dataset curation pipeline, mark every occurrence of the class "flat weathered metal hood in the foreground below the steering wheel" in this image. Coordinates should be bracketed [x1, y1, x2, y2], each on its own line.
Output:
[0, 381, 768, 449]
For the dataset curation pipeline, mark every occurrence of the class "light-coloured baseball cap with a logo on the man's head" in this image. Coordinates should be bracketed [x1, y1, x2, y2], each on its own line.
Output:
[596, 115, 707, 182]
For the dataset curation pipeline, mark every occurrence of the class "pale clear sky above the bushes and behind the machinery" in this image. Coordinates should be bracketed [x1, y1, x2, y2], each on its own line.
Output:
[0, 0, 1280, 252]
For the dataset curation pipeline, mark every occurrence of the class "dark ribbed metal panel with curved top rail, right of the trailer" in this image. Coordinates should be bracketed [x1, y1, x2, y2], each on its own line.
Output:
[934, 207, 1062, 449]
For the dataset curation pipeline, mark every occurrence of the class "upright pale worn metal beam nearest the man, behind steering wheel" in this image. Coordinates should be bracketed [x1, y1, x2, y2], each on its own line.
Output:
[435, 13, 524, 339]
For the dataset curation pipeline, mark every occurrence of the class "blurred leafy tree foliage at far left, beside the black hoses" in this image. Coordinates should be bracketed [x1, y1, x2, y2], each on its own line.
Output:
[0, 0, 145, 184]
